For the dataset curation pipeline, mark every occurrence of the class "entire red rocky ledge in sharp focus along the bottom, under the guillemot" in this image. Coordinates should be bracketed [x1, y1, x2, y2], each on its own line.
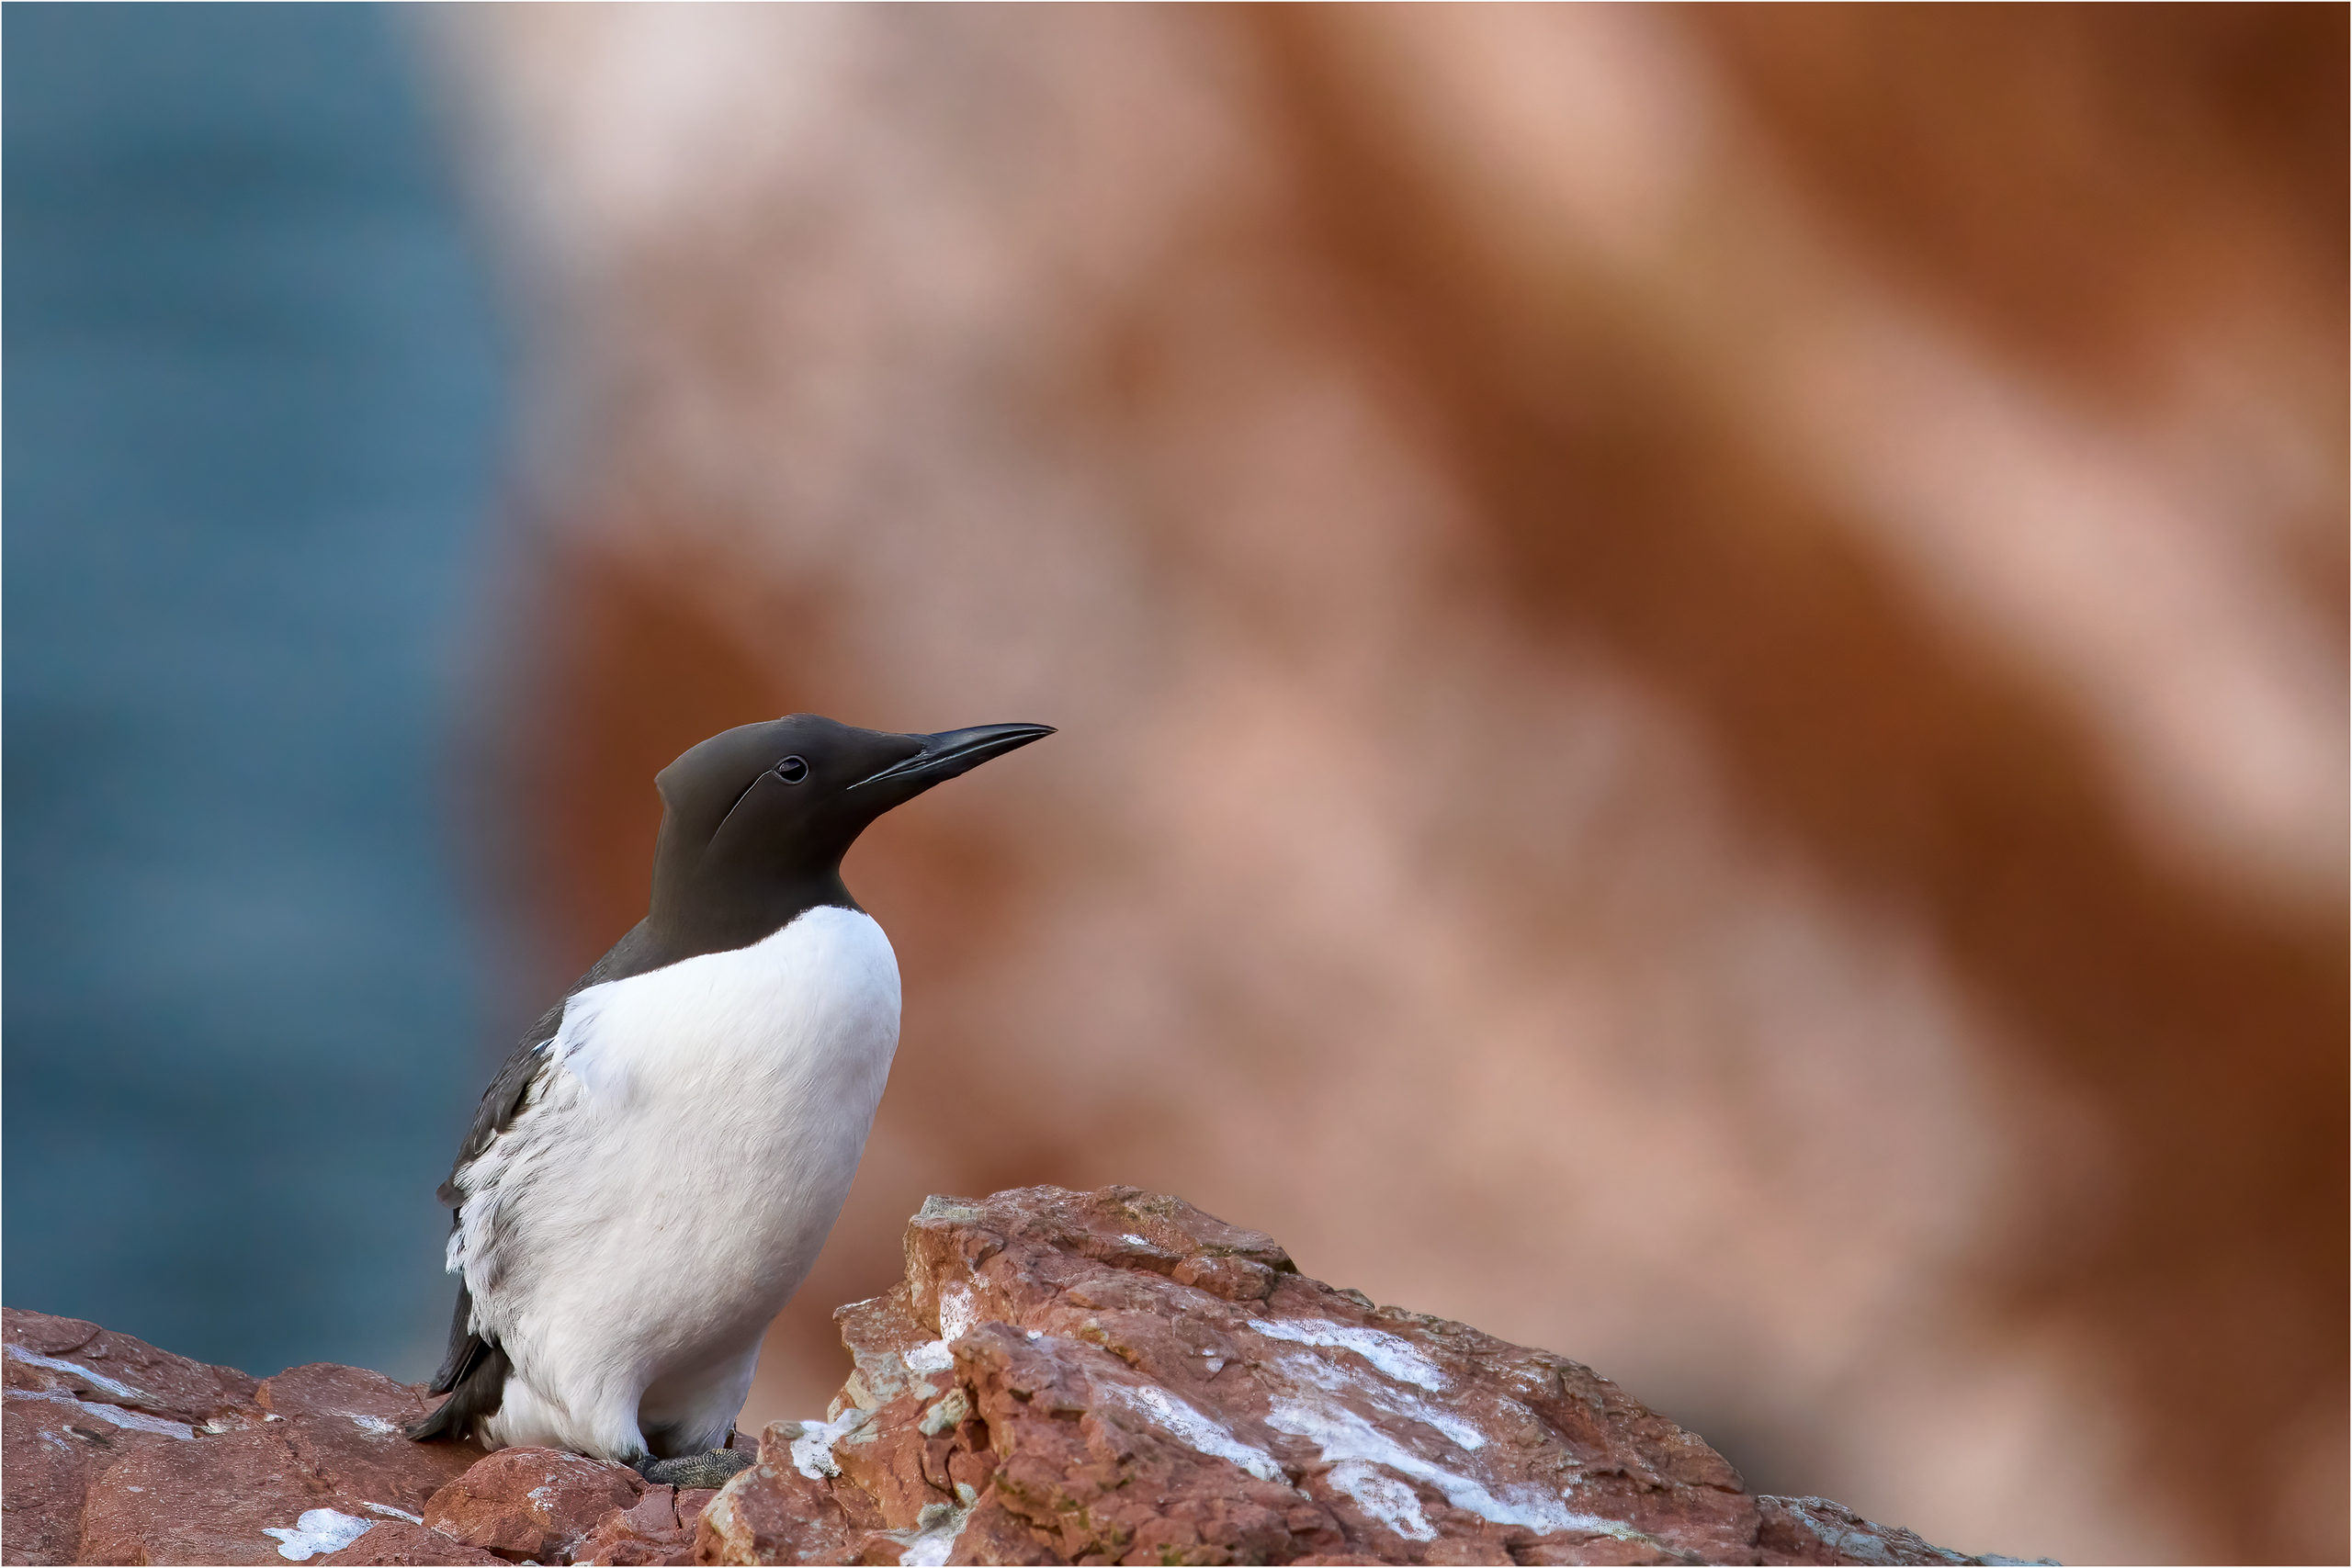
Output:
[0, 1187, 2011, 1565]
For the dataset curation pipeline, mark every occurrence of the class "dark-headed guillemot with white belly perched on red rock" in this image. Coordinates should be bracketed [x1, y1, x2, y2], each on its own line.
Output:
[409, 712, 1054, 1485]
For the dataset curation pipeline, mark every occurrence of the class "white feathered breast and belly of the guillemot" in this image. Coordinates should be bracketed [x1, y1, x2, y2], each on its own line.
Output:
[452, 908, 899, 1458]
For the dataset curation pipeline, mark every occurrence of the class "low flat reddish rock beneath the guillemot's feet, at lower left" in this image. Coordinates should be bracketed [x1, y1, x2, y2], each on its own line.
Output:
[0, 1309, 751, 1565]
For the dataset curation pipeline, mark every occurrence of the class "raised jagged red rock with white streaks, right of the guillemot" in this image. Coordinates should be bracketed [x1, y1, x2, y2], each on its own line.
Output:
[696, 1187, 2031, 1563]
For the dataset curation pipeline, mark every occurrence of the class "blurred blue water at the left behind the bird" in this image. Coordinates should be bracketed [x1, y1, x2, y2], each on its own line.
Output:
[0, 5, 501, 1378]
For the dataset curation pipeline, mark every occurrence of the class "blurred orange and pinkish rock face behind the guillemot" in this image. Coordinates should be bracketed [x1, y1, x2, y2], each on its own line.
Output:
[423, 7, 2345, 1561]
